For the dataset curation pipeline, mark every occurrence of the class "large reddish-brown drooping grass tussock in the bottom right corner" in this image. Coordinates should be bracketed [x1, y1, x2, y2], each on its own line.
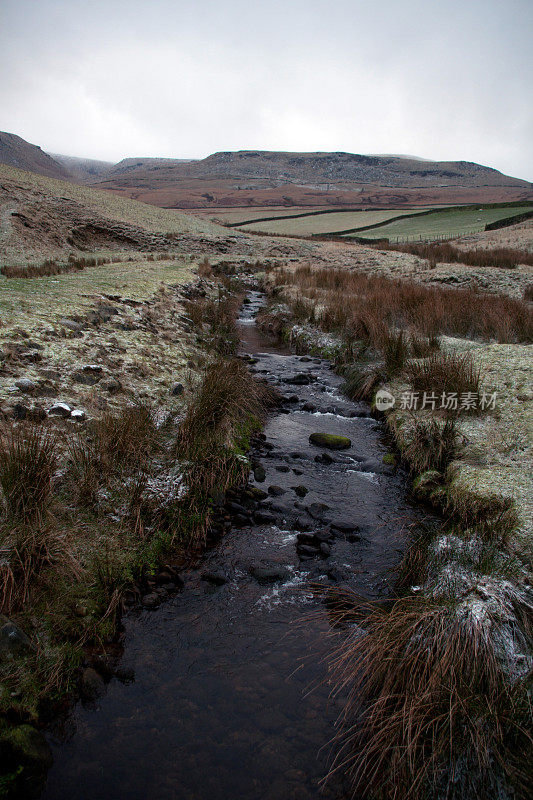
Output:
[333, 597, 531, 800]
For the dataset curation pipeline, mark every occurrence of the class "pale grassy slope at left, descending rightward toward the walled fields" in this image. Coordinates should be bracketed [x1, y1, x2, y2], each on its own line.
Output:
[0, 166, 246, 263]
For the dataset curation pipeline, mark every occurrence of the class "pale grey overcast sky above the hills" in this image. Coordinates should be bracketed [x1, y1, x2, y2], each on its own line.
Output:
[0, 0, 533, 180]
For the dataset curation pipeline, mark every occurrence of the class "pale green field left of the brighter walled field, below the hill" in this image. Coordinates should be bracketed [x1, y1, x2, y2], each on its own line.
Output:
[235, 206, 434, 236]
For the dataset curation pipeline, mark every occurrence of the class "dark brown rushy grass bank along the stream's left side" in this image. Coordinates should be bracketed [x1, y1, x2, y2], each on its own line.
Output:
[0, 272, 273, 796]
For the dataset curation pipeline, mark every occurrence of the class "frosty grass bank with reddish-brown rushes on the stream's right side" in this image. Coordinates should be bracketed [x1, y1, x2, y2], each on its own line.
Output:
[256, 268, 533, 798]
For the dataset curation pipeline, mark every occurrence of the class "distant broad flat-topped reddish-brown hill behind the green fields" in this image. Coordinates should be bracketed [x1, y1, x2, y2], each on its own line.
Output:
[89, 150, 533, 208]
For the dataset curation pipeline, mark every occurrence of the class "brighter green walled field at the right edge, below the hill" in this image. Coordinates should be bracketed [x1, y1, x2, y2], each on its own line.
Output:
[340, 204, 533, 242]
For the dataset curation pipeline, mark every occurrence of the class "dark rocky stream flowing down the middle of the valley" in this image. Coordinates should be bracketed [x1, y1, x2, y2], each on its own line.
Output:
[42, 294, 424, 800]
